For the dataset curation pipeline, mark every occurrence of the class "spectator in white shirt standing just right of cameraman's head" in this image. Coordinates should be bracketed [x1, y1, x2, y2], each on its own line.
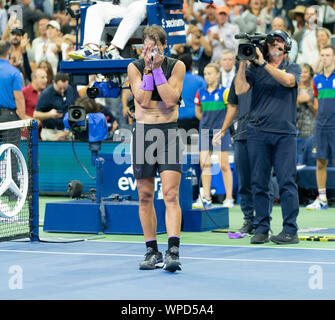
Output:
[293, 7, 318, 66]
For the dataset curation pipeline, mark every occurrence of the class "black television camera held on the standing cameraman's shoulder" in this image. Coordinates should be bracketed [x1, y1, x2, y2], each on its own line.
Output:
[235, 33, 267, 61]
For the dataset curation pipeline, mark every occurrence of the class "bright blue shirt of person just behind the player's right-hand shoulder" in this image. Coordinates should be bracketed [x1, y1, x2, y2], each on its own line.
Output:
[178, 71, 207, 119]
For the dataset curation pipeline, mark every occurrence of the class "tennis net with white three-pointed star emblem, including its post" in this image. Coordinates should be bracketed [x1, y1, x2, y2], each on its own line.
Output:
[0, 120, 39, 241]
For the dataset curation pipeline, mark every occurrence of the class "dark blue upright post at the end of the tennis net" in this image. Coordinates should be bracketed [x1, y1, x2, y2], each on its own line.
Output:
[30, 120, 39, 242]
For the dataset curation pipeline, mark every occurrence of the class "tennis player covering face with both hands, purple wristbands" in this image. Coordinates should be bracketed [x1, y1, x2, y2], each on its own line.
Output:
[128, 25, 185, 272]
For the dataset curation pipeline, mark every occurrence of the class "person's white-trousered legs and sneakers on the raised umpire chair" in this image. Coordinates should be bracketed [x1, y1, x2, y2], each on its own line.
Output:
[69, 0, 147, 60]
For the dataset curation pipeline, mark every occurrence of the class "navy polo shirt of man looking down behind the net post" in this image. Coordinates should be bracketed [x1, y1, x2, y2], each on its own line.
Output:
[35, 84, 79, 130]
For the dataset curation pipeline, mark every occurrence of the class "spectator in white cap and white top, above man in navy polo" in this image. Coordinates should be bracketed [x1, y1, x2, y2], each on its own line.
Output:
[35, 20, 63, 74]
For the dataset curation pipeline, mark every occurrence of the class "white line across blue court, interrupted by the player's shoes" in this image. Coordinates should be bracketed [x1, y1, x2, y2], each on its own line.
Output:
[0, 249, 335, 265]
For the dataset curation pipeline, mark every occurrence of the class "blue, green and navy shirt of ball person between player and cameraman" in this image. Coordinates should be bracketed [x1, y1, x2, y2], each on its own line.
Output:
[194, 84, 229, 129]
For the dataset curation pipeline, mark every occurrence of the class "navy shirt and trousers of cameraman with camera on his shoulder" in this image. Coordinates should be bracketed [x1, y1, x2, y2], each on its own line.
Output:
[246, 60, 301, 235]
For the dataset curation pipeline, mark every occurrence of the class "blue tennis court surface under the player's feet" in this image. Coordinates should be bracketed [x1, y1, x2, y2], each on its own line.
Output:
[0, 240, 335, 300]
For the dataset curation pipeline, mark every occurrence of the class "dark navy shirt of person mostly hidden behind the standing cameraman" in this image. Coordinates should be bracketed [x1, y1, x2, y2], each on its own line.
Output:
[228, 77, 252, 140]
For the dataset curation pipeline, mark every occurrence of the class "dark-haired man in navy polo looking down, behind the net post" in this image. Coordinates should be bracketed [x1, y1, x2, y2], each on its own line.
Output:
[34, 73, 78, 141]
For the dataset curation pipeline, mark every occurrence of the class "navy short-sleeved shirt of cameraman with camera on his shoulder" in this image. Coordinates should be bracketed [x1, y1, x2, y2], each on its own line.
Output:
[246, 60, 301, 135]
